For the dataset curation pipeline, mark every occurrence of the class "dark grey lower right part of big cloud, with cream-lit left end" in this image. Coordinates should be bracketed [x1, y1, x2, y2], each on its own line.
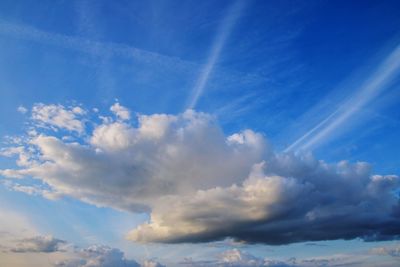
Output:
[130, 158, 400, 245]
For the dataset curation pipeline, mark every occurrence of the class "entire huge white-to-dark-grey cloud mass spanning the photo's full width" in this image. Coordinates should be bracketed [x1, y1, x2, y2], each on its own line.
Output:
[1, 103, 400, 244]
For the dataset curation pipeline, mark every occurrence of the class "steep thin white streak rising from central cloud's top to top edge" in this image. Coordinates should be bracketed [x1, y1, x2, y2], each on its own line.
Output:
[186, 0, 244, 109]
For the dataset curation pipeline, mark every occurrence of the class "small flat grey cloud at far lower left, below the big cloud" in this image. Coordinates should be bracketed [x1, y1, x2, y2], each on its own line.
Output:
[10, 236, 66, 253]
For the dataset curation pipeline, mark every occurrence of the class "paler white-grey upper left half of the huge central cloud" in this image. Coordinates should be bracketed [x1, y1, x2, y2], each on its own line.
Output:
[2, 107, 265, 214]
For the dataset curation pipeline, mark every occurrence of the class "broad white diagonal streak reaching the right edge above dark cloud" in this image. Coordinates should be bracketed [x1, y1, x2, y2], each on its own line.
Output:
[285, 45, 400, 152]
